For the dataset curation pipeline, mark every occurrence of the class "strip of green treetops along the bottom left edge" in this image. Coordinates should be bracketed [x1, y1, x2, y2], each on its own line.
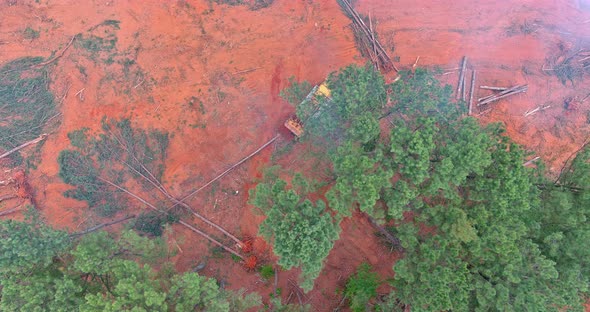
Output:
[0, 217, 260, 311]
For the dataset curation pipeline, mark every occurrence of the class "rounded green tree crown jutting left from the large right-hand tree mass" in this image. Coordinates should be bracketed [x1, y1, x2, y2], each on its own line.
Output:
[250, 176, 340, 291]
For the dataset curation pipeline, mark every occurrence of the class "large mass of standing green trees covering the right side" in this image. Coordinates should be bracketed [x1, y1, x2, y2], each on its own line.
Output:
[251, 66, 590, 311]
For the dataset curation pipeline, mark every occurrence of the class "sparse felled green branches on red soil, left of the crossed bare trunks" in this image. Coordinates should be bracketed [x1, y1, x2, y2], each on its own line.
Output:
[58, 119, 169, 218]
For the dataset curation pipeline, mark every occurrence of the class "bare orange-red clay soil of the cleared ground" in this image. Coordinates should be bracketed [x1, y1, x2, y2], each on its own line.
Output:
[0, 0, 590, 311]
